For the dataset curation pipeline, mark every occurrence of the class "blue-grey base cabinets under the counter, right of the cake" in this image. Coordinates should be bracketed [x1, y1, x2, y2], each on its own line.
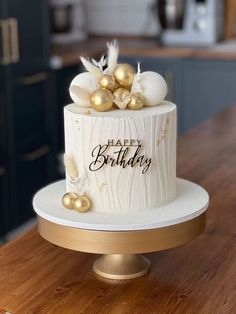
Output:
[120, 56, 236, 133]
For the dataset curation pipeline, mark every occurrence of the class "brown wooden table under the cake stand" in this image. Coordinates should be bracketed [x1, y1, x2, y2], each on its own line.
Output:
[0, 106, 236, 314]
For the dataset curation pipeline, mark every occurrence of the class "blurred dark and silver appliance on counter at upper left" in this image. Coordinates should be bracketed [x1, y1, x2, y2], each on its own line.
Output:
[50, 0, 87, 44]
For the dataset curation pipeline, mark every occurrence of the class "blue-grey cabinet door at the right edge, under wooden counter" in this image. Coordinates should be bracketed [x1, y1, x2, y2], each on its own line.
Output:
[182, 60, 236, 131]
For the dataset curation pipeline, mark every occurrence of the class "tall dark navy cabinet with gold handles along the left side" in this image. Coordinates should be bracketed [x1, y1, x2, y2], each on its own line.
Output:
[0, 0, 58, 233]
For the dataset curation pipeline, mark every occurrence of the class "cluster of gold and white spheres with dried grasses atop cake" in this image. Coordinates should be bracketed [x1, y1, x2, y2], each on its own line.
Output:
[69, 40, 167, 111]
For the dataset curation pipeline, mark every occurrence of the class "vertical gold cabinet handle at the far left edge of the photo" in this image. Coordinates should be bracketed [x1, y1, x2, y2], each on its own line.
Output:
[0, 19, 11, 65]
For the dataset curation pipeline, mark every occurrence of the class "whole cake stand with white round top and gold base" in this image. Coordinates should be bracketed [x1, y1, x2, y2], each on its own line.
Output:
[33, 179, 209, 280]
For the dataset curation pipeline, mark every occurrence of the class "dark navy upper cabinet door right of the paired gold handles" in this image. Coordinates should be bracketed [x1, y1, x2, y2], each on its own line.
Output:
[7, 0, 50, 78]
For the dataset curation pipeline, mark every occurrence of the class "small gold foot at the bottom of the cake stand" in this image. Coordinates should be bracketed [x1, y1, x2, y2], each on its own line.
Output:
[93, 254, 151, 280]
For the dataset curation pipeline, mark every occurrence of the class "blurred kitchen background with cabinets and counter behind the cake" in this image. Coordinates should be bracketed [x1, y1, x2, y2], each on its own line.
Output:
[0, 0, 236, 242]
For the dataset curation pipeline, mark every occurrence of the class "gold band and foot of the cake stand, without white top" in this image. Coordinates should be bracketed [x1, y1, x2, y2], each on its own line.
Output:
[38, 212, 206, 280]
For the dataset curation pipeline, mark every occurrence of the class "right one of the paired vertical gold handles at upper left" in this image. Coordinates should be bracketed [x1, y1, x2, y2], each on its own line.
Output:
[8, 17, 20, 63]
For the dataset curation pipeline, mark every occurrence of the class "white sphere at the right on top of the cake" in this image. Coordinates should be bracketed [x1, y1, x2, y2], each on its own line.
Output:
[139, 71, 167, 106]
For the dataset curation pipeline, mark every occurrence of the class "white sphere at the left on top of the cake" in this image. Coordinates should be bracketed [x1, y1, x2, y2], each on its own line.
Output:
[69, 72, 98, 107]
